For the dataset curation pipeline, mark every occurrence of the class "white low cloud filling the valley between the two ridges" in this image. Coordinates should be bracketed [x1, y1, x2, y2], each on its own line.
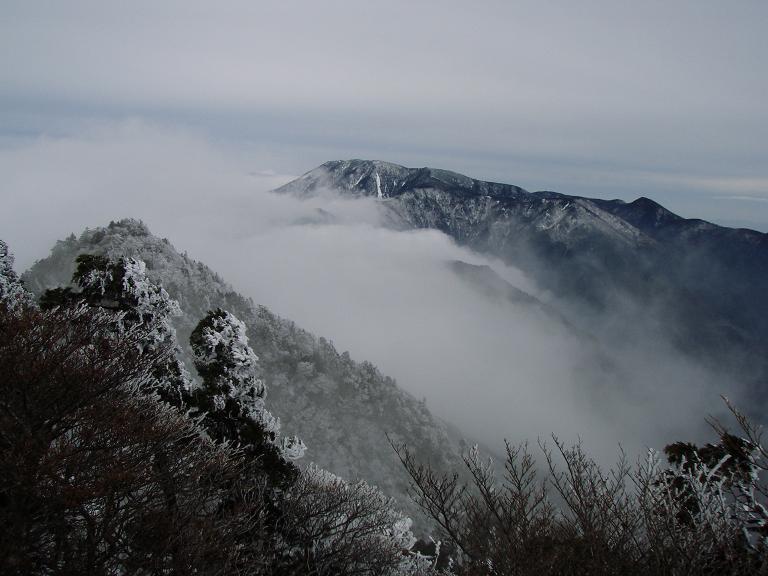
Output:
[0, 122, 731, 460]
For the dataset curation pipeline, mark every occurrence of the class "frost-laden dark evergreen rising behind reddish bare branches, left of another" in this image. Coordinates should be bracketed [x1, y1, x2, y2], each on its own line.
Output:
[40, 254, 190, 406]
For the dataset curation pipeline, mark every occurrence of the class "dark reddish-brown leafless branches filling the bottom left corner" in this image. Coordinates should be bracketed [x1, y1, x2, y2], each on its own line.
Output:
[0, 294, 267, 576]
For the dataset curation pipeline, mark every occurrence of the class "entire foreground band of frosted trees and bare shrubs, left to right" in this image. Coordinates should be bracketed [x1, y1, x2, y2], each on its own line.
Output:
[0, 237, 768, 575]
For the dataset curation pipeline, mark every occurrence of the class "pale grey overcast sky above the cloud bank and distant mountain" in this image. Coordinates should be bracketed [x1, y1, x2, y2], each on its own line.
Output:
[0, 0, 768, 230]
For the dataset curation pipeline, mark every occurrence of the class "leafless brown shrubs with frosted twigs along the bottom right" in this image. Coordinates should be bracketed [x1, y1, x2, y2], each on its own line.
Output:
[393, 405, 768, 575]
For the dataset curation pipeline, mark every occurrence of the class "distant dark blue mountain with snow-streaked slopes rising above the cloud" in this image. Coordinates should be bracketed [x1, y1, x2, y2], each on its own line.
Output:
[276, 160, 768, 393]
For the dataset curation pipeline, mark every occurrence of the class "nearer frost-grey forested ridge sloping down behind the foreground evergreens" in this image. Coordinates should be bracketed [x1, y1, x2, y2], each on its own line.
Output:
[24, 219, 463, 518]
